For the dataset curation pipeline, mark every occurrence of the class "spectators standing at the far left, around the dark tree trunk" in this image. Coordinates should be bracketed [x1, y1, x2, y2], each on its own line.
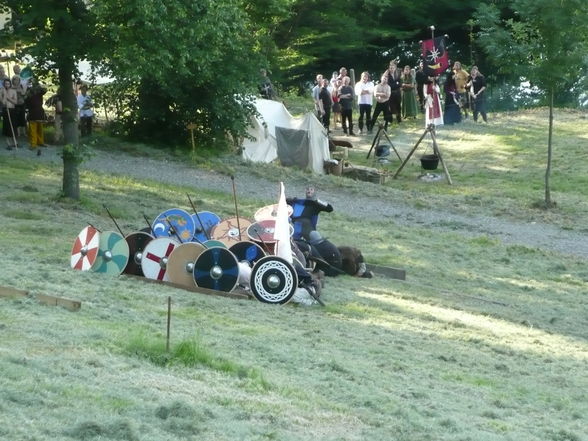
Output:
[0, 65, 94, 155]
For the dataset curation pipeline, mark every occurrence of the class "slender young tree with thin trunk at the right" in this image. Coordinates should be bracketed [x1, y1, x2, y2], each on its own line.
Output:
[476, 0, 588, 207]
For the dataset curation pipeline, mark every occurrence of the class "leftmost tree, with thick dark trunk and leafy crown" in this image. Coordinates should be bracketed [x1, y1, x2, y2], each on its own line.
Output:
[0, 0, 99, 199]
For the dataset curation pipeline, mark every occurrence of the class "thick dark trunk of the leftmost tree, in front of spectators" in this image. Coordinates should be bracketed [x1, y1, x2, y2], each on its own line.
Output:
[58, 56, 81, 200]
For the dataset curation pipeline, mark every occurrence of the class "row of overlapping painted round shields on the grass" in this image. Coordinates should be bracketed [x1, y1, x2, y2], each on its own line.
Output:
[70, 206, 298, 304]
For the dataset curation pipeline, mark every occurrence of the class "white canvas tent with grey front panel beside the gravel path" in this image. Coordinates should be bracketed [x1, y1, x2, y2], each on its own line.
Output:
[243, 99, 330, 173]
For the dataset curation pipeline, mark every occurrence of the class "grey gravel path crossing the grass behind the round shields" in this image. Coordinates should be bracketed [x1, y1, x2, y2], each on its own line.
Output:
[5, 142, 588, 259]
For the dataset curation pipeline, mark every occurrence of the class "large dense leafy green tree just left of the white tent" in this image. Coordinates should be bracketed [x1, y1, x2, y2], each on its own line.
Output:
[93, 0, 265, 143]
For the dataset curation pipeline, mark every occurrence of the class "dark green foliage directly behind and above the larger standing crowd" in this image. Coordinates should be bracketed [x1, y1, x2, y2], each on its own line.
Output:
[267, 0, 480, 85]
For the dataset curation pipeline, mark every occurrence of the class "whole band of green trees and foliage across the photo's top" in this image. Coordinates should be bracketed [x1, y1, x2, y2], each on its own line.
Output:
[0, 0, 587, 142]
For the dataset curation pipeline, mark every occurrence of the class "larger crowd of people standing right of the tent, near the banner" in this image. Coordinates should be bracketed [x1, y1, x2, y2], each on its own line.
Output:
[312, 60, 487, 136]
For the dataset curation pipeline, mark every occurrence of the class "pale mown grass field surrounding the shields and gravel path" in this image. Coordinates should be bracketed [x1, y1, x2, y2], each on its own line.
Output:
[0, 110, 588, 441]
